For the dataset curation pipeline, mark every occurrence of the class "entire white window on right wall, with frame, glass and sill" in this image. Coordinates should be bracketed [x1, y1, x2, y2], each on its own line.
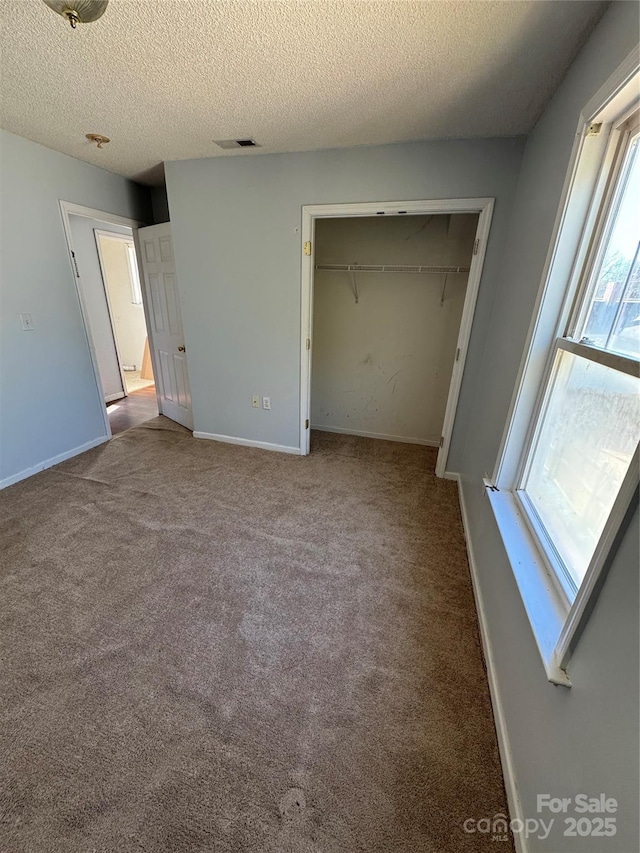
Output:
[487, 65, 640, 684]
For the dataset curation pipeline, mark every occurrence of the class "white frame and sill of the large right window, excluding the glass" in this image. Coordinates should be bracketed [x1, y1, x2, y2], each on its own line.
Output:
[484, 54, 640, 686]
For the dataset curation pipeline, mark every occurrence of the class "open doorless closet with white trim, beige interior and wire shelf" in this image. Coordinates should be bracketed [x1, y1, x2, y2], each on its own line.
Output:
[301, 199, 492, 476]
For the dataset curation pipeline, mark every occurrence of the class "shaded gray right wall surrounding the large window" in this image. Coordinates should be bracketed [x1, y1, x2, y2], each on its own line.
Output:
[461, 2, 640, 853]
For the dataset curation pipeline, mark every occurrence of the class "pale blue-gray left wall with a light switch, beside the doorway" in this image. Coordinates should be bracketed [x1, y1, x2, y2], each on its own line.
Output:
[0, 132, 149, 482]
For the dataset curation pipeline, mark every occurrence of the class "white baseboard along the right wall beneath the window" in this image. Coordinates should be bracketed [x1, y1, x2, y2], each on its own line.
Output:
[456, 472, 529, 853]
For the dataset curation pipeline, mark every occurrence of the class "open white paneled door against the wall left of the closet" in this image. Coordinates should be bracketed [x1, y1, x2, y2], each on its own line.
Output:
[138, 222, 193, 429]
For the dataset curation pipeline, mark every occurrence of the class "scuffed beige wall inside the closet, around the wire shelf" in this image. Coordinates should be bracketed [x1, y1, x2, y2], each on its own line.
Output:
[311, 215, 478, 445]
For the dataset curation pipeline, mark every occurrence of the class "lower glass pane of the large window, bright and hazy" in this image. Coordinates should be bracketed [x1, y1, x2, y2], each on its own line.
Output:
[524, 350, 640, 588]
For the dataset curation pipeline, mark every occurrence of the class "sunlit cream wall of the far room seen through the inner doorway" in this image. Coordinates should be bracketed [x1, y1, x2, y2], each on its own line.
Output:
[100, 237, 147, 370]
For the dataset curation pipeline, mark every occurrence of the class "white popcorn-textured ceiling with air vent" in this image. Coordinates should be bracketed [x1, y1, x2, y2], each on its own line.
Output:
[0, 0, 606, 183]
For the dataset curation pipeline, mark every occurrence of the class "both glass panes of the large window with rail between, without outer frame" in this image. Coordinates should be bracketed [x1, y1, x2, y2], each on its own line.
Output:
[516, 114, 640, 603]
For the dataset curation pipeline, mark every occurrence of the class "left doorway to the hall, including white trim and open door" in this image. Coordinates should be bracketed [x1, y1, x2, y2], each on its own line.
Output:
[60, 200, 193, 438]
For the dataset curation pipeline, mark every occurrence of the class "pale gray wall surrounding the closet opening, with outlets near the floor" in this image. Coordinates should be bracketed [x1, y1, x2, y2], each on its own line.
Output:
[165, 139, 523, 456]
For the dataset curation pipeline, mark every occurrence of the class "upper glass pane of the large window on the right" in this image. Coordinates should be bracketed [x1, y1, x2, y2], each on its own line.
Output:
[580, 131, 640, 358]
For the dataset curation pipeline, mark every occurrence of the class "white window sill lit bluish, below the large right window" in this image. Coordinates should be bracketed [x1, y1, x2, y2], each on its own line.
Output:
[485, 480, 571, 687]
